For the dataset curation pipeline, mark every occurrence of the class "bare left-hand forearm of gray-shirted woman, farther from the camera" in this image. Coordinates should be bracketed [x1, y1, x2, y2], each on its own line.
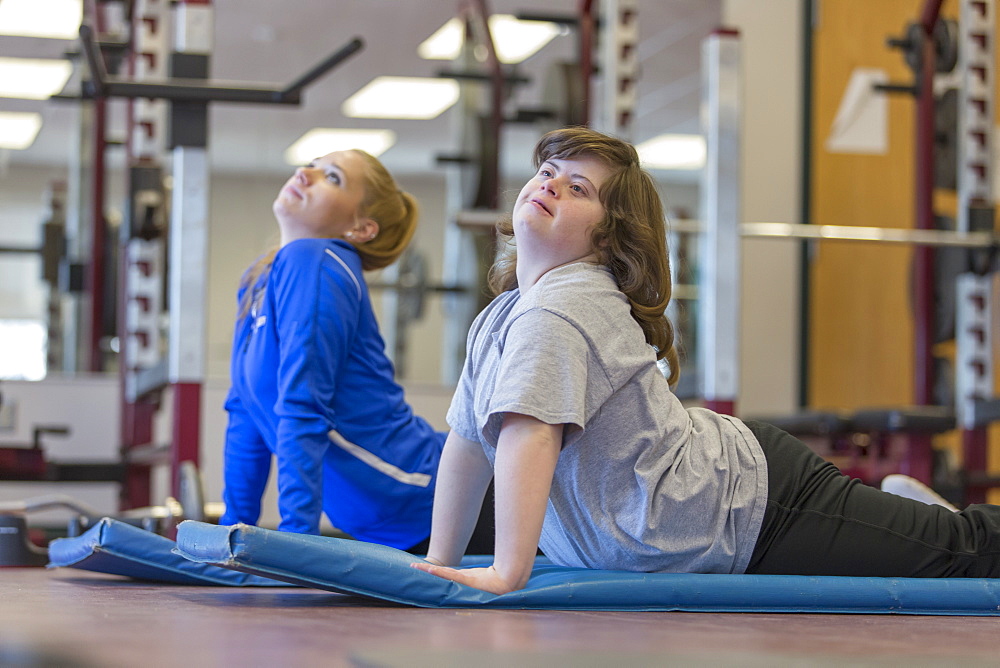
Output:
[427, 431, 493, 565]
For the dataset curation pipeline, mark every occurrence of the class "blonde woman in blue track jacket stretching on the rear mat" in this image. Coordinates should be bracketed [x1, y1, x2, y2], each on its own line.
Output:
[221, 151, 492, 552]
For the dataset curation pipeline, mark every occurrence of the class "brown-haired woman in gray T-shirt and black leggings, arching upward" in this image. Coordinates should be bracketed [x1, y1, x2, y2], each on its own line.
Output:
[414, 128, 1000, 594]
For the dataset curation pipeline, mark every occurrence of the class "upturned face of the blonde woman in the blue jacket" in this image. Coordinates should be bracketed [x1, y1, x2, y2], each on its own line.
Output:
[271, 151, 365, 243]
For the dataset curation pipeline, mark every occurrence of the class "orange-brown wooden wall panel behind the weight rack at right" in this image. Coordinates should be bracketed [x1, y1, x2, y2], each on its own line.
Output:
[808, 0, 1000, 494]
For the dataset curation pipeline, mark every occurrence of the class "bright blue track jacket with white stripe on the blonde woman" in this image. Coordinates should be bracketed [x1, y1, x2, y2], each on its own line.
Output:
[222, 239, 445, 549]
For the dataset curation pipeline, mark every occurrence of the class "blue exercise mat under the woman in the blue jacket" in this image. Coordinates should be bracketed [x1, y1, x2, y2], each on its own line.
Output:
[48, 517, 288, 587]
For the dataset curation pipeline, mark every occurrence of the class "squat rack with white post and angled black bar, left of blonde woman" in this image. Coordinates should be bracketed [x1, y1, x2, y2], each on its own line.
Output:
[73, 0, 363, 508]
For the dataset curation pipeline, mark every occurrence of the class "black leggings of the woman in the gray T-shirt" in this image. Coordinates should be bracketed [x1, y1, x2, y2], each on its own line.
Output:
[746, 421, 1000, 578]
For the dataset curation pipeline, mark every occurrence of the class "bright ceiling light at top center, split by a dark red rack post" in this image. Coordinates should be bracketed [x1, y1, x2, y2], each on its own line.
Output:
[417, 14, 561, 65]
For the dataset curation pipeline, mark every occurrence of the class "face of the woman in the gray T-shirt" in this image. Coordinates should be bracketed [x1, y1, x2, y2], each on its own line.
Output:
[514, 156, 611, 266]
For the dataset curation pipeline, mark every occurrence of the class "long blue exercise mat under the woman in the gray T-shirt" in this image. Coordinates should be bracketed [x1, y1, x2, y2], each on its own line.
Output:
[177, 521, 1000, 616]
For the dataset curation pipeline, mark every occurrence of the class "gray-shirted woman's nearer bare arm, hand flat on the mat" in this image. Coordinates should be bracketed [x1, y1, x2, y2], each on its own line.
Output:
[414, 413, 563, 594]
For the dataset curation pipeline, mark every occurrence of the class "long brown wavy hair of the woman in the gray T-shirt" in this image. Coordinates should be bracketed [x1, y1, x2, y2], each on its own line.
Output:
[490, 127, 680, 385]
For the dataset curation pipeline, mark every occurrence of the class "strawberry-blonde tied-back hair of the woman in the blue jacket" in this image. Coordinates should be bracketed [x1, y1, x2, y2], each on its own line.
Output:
[239, 149, 420, 318]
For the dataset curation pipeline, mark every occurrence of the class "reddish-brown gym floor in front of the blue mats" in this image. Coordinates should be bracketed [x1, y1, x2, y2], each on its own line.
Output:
[0, 568, 1000, 668]
